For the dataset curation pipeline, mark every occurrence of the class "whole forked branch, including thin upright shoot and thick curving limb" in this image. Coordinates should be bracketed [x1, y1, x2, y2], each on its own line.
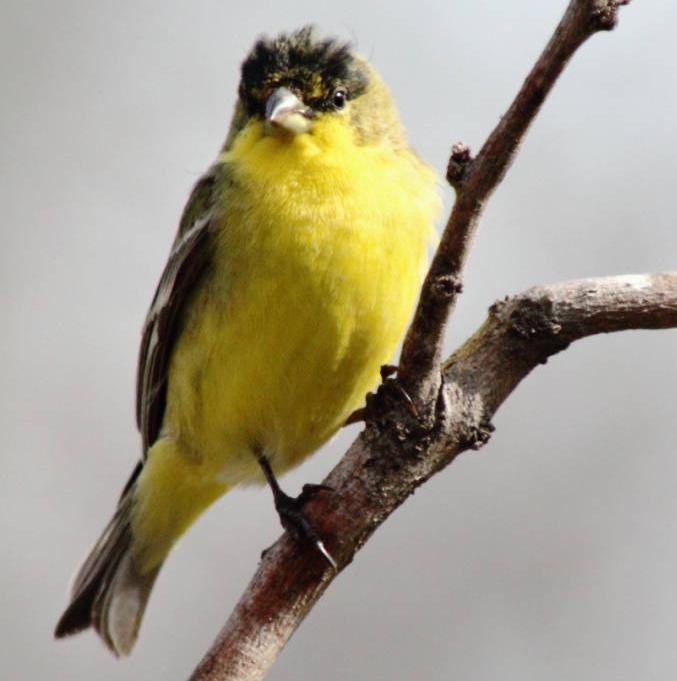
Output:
[191, 0, 644, 681]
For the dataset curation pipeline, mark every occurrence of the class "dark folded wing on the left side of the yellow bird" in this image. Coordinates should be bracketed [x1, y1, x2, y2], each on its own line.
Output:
[136, 166, 223, 458]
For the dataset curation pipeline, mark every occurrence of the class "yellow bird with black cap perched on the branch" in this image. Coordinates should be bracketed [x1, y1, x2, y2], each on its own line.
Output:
[55, 25, 440, 656]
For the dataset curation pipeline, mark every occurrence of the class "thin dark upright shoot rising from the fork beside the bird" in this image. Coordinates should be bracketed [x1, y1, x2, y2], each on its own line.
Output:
[399, 0, 629, 413]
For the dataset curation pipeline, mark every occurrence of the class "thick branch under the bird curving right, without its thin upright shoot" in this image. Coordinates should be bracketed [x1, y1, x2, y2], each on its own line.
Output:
[191, 272, 677, 681]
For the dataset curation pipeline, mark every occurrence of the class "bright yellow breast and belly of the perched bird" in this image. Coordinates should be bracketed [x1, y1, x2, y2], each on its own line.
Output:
[165, 120, 438, 486]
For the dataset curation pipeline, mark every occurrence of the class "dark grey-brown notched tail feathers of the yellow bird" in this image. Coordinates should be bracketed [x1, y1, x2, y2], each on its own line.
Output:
[54, 464, 162, 655]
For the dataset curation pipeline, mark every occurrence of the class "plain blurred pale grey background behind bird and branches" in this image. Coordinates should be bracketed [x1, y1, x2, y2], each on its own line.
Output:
[0, 0, 677, 681]
